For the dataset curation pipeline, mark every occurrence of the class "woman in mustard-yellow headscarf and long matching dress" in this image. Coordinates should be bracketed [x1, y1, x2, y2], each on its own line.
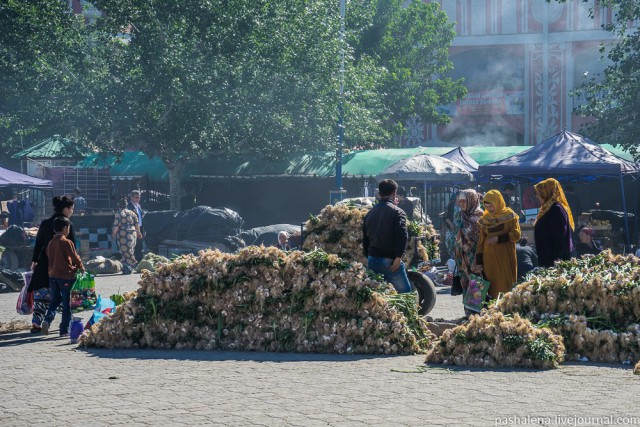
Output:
[475, 190, 520, 298]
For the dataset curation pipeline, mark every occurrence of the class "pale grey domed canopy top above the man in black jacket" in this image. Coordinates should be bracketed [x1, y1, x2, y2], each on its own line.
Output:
[376, 154, 473, 182]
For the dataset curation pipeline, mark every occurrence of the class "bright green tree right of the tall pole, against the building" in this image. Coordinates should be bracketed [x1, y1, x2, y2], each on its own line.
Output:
[354, 0, 467, 142]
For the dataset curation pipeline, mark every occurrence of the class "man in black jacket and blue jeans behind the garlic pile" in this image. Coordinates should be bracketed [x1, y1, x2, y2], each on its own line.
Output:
[362, 179, 411, 293]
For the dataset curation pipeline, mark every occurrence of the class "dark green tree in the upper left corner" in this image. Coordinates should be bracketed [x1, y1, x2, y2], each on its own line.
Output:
[0, 0, 100, 157]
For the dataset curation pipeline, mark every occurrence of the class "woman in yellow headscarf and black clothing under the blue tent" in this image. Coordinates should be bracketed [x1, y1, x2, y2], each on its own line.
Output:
[534, 178, 574, 267]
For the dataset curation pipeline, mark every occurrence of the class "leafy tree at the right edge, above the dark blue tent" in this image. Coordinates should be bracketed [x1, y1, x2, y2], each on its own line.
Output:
[559, 0, 640, 160]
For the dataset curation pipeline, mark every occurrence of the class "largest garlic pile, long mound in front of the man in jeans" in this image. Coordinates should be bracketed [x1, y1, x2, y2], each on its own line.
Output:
[80, 246, 431, 354]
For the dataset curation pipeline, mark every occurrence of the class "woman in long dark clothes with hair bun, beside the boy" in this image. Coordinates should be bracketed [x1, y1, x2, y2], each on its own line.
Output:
[29, 196, 75, 333]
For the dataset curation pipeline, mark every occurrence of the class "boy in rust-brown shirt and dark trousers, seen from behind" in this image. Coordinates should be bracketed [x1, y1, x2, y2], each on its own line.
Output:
[42, 217, 84, 337]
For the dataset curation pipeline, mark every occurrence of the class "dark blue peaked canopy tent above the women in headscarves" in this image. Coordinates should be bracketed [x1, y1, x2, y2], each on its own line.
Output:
[478, 130, 640, 245]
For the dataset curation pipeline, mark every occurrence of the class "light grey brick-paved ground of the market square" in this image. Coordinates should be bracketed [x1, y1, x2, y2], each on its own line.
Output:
[0, 275, 640, 426]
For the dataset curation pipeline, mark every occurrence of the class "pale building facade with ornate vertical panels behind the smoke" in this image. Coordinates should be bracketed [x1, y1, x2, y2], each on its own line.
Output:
[401, 0, 613, 147]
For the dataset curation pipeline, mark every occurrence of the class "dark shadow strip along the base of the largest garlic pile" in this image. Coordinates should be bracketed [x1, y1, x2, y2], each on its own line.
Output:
[77, 347, 402, 362]
